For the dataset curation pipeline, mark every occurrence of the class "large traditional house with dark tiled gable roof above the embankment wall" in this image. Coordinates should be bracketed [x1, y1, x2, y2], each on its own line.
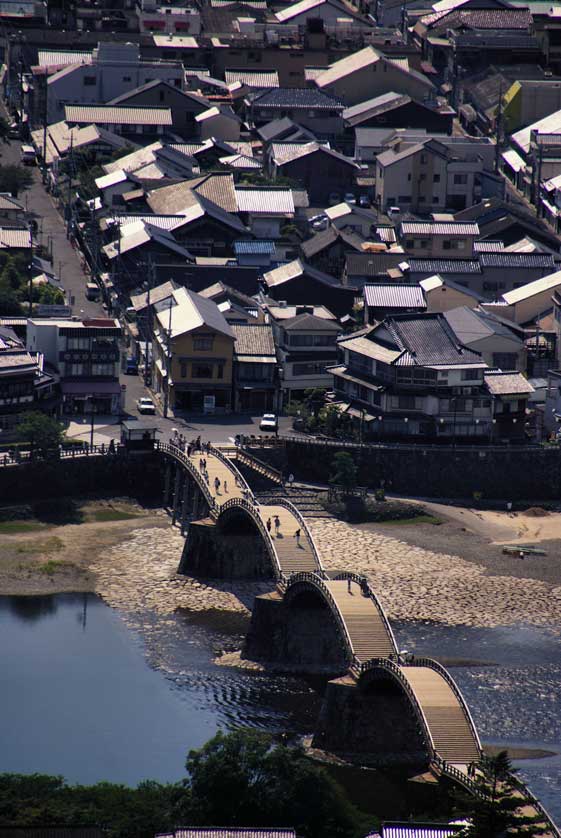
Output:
[330, 314, 531, 441]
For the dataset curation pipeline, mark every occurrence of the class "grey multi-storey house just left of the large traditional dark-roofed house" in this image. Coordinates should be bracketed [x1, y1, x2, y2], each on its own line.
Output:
[266, 305, 342, 405]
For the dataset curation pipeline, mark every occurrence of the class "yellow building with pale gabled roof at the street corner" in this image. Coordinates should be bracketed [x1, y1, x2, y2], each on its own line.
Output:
[152, 288, 235, 413]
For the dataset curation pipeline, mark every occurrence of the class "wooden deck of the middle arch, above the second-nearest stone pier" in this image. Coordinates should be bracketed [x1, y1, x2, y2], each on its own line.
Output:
[325, 580, 397, 663]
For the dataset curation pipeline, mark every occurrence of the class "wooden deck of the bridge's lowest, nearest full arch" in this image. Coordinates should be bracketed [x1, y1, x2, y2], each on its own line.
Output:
[401, 666, 480, 765]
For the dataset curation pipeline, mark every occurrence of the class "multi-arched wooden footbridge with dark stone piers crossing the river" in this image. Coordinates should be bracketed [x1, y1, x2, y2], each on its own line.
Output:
[158, 443, 561, 838]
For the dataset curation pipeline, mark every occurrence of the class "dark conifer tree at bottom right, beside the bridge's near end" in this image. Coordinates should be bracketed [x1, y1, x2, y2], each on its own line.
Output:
[459, 751, 547, 838]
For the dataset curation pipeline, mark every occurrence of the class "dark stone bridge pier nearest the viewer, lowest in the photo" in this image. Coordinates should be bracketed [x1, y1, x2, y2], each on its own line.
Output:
[312, 675, 429, 765]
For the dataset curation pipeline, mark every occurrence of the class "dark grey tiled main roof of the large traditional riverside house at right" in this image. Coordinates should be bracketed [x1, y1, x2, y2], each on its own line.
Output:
[384, 314, 484, 367]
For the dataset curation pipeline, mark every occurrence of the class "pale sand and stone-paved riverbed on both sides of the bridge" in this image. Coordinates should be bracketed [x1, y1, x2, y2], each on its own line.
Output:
[0, 500, 561, 628]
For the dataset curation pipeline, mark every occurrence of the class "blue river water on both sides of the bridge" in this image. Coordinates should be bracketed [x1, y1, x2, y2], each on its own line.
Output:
[0, 594, 561, 821]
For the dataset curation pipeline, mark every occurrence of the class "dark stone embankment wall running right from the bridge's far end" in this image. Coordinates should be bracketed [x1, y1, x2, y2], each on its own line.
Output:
[247, 441, 561, 500]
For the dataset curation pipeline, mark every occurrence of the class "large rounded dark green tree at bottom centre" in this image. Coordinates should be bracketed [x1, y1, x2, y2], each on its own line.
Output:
[187, 730, 363, 838]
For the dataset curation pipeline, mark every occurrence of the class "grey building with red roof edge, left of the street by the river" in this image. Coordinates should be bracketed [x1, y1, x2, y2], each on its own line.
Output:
[27, 317, 122, 415]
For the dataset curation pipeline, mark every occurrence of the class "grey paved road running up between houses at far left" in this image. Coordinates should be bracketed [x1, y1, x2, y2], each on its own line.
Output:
[0, 125, 104, 317]
